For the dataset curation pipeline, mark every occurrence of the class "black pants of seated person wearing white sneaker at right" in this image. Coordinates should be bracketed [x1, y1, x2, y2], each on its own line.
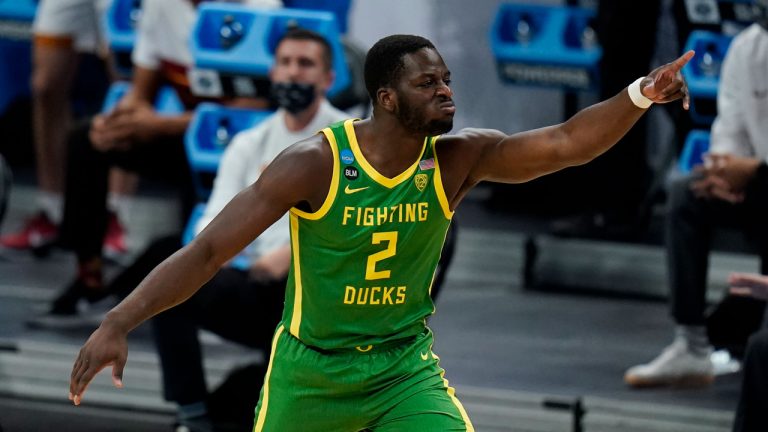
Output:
[666, 169, 768, 325]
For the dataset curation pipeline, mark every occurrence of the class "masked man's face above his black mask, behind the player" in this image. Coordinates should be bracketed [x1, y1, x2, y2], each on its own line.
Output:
[270, 39, 333, 94]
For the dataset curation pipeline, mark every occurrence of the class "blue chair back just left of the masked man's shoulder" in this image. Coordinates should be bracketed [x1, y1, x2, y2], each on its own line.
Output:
[184, 102, 272, 201]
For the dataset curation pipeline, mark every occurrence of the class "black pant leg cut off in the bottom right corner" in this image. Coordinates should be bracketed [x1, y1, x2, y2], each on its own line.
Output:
[733, 329, 768, 432]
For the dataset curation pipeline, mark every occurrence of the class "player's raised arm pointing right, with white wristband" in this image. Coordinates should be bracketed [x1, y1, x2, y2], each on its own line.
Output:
[467, 51, 694, 183]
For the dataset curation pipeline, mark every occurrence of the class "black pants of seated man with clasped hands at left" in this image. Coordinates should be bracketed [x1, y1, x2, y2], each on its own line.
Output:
[61, 121, 194, 262]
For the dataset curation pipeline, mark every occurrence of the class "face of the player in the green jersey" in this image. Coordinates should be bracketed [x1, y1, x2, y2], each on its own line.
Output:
[395, 48, 456, 136]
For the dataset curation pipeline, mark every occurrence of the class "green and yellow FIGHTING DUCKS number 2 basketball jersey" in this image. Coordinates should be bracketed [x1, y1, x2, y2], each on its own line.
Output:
[283, 120, 453, 351]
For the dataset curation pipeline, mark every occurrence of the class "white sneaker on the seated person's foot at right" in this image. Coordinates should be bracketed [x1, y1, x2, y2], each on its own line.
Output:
[624, 339, 715, 387]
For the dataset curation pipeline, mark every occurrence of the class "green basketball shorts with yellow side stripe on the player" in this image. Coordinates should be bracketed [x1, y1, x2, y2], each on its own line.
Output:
[254, 325, 474, 432]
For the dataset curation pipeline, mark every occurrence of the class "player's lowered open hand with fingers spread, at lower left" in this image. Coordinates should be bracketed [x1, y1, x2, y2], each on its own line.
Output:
[69, 323, 128, 405]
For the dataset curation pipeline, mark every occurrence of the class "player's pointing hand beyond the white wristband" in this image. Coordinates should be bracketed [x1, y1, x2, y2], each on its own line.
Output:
[640, 51, 695, 109]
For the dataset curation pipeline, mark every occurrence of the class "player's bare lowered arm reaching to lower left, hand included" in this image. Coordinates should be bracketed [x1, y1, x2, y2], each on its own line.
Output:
[69, 135, 333, 405]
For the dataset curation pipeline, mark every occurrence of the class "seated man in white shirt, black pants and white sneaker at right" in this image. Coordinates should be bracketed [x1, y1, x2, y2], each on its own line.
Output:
[624, 8, 768, 387]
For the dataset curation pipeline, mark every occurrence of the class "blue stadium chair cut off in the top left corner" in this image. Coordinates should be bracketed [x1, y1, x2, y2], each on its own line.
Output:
[0, 0, 37, 114]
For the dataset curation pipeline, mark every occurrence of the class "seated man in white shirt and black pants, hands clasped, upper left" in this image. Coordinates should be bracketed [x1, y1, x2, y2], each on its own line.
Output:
[30, 0, 276, 327]
